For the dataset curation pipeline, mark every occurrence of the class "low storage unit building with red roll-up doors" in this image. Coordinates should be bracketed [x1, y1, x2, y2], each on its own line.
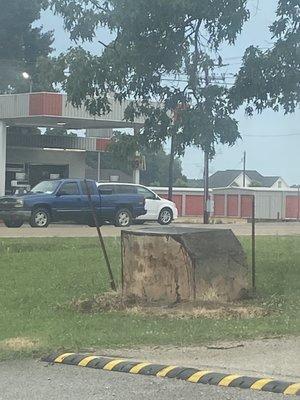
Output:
[152, 187, 300, 221]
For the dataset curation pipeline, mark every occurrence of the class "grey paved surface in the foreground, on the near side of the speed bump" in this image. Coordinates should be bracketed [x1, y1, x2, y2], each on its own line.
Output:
[0, 361, 287, 400]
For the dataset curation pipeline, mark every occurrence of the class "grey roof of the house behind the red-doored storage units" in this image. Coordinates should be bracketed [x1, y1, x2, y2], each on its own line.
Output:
[200, 169, 280, 188]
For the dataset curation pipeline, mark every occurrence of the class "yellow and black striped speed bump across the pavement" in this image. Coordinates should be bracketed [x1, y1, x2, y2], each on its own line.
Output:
[42, 353, 300, 395]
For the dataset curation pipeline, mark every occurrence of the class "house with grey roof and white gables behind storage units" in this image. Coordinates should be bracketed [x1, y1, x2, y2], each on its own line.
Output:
[200, 169, 289, 189]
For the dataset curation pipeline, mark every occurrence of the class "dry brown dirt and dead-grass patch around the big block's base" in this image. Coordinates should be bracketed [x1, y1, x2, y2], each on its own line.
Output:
[68, 292, 271, 319]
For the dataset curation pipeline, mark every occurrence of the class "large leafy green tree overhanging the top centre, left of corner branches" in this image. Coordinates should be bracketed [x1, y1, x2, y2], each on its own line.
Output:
[51, 0, 249, 198]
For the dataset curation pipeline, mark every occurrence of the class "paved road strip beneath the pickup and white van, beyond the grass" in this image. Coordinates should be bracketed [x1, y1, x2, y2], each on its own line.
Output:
[0, 222, 300, 238]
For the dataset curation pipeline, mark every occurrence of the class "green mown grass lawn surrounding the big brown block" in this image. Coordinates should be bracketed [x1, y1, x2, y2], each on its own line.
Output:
[0, 237, 300, 360]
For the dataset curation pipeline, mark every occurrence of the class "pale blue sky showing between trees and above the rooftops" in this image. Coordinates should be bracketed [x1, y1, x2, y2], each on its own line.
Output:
[40, 0, 300, 185]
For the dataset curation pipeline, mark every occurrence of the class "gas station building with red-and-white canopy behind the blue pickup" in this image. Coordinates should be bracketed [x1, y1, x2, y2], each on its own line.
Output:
[0, 93, 144, 196]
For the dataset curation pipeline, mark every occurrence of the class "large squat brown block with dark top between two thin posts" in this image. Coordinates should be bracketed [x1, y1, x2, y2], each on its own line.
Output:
[121, 227, 250, 305]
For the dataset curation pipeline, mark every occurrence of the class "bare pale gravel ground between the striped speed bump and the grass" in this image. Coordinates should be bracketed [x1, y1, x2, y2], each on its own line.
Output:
[92, 337, 300, 382]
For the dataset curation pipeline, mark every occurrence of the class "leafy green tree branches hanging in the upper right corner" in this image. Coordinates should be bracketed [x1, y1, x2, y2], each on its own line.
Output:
[231, 0, 300, 115]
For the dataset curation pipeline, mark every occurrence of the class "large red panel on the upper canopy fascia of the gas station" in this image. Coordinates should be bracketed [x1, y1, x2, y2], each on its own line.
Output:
[29, 93, 62, 117]
